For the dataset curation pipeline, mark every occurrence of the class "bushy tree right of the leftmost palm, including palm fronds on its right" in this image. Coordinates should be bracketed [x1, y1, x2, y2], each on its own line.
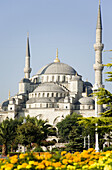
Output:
[17, 116, 53, 148]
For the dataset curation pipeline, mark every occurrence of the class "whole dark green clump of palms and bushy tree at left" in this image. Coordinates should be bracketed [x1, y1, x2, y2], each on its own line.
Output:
[0, 116, 56, 155]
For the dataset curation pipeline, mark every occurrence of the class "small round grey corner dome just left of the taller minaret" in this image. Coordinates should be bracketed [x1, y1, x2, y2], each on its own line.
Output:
[79, 97, 95, 105]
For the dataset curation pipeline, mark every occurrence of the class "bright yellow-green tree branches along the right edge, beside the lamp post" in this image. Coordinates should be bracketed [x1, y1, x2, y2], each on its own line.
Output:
[85, 59, 112, 148]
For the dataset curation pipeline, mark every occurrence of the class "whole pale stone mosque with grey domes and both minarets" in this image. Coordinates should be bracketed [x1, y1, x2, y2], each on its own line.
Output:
[0, 3, 104, 126]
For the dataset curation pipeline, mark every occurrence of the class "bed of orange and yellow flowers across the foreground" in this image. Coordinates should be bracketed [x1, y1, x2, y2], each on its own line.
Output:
[0, 148, 112, 170]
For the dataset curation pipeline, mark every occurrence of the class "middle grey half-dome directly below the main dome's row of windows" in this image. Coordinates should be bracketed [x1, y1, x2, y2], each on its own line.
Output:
[34, 83, 64, 93]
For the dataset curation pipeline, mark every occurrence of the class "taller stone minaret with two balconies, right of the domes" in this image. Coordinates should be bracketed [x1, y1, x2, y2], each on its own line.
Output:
[93, 0, 104, 87]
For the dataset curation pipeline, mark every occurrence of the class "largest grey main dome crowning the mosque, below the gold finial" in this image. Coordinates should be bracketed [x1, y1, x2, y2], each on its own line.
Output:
[37, 62, 76, 75]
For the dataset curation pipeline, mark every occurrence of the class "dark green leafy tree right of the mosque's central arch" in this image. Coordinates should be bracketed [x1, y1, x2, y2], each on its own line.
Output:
[57, 113, 84, 151]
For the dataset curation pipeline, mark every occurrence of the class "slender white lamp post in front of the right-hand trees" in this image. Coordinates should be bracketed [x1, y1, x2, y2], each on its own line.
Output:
[93, 83, 99, 152]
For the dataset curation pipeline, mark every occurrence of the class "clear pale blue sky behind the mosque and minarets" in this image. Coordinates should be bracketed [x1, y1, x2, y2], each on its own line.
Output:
[0, 0, 112, 102]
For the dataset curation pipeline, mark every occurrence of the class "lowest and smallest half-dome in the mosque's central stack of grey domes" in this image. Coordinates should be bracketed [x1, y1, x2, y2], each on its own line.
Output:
[27, 97, 52, 104]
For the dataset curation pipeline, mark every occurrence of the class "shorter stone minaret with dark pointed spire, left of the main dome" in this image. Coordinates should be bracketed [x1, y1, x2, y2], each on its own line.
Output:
[24, 34, 32, 79]
